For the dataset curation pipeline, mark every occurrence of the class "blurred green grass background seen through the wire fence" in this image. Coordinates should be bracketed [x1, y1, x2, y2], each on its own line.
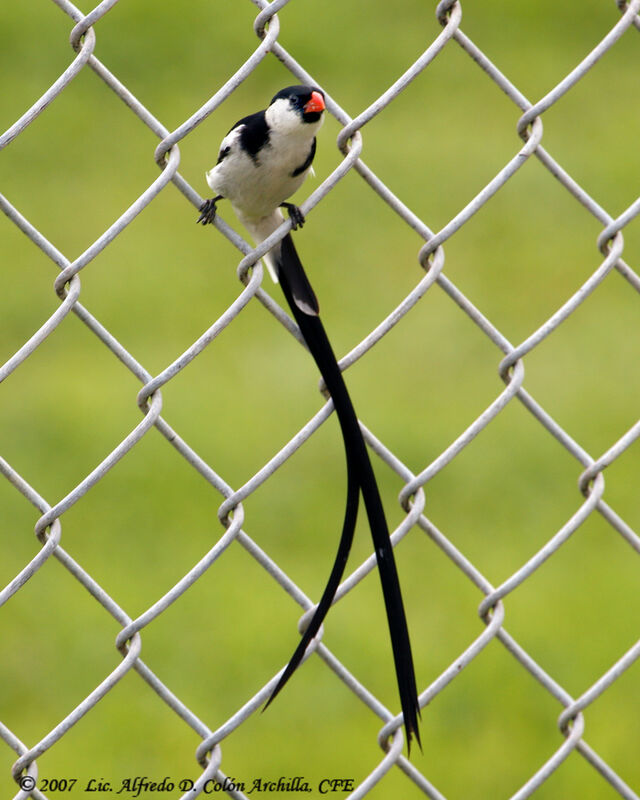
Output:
[0, 0, 640, 800]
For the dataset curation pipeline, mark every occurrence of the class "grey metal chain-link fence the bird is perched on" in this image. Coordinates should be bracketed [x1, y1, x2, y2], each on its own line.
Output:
[0, 0, 640, 800]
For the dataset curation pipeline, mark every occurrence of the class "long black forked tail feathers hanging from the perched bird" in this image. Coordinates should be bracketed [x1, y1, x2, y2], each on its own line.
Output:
[265, 234, 421, 749]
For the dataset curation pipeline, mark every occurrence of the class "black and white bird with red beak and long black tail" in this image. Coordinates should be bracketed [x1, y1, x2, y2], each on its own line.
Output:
[198, 86, 420, 748]
